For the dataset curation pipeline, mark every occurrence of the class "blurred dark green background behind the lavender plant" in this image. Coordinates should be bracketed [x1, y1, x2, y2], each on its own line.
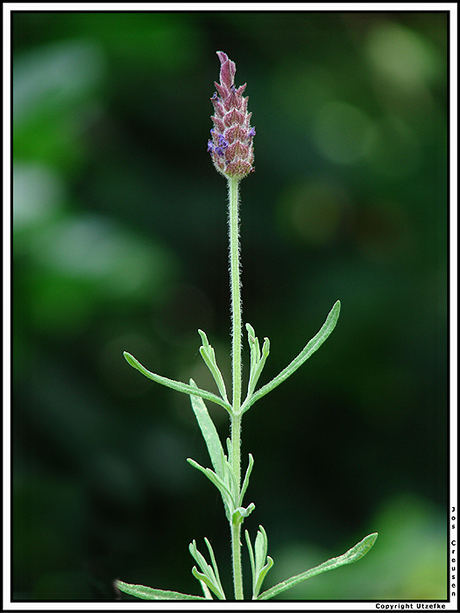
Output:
[12, 11, 449, 601]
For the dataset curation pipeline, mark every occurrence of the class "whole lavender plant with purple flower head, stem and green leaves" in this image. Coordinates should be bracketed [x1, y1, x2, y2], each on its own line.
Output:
[116, 51, 377, 600]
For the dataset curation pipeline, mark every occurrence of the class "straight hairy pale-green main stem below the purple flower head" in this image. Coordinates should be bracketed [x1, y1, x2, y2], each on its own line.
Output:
[228, 178, 244, 600]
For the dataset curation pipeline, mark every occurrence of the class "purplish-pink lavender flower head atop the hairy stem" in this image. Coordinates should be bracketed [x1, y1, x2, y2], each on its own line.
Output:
[208, 51, 256, 179]
